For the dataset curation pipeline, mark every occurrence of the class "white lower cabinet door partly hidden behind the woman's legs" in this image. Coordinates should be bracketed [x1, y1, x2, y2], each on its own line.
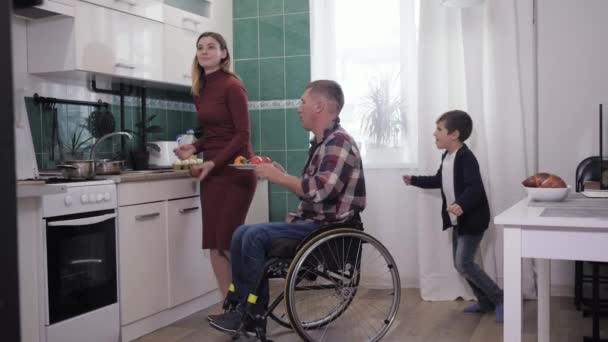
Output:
[167, 197, 217, 307]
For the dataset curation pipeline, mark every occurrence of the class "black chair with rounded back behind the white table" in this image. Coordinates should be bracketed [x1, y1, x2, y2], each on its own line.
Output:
[574, 156, 608, 341]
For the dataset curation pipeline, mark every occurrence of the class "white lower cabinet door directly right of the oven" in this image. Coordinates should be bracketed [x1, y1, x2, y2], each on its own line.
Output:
[118, 202, 169, 325]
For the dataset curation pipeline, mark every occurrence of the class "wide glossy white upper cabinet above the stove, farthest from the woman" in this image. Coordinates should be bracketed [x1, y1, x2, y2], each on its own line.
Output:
[28, 1, 163, 81]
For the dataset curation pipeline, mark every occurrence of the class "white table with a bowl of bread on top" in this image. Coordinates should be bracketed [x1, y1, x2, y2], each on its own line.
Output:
[494, 199, 608, 342]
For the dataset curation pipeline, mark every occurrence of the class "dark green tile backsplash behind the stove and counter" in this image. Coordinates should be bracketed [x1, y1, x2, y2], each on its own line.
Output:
[26, 89, 199, 170]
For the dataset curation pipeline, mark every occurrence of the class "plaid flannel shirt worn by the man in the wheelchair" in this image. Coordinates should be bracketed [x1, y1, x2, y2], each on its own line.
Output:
[288, 119, 365, 223]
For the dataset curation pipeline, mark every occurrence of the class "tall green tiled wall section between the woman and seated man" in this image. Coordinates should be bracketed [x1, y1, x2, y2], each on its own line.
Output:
[232, 0, 310, 221]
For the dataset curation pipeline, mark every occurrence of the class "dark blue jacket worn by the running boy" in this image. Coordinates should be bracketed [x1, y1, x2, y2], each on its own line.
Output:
[411, 144, 490, 235]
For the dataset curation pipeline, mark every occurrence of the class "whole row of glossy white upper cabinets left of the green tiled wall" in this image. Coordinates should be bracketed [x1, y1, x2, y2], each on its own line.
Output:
[27, 0, 232, 86]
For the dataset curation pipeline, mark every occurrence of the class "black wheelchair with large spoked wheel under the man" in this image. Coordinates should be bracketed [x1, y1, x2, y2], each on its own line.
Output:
[228, 222, 401, 342]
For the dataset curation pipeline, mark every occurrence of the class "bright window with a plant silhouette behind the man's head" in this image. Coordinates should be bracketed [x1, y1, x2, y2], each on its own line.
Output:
[311, 0, 418, 167]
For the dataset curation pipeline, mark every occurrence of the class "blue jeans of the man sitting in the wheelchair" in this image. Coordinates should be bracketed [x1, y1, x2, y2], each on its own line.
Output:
[230, 221, 319, 305]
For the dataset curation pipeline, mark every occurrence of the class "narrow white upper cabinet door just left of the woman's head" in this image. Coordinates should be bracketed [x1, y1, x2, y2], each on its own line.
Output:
[163, 24, 198, 86]
